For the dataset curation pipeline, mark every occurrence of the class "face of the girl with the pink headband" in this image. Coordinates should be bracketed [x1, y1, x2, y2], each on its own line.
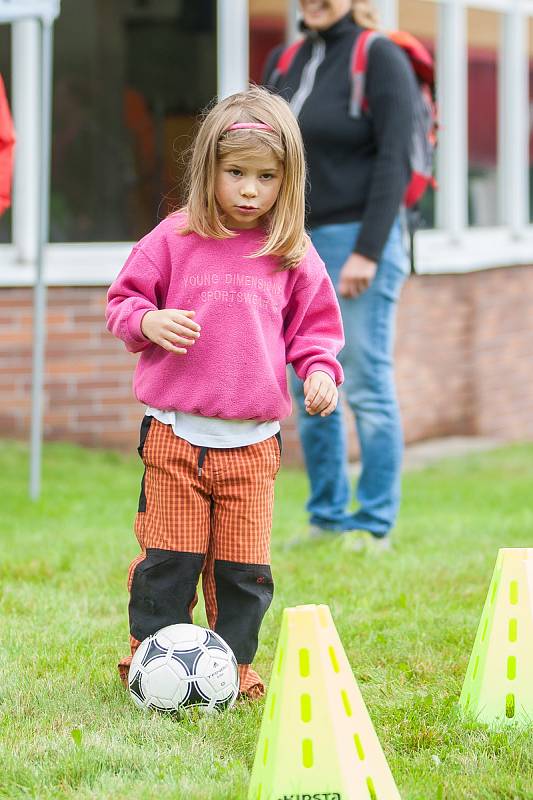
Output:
[215, 153, 283, 228]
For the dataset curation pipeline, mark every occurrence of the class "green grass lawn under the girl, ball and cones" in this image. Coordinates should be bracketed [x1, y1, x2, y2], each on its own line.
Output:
[0, 443, 533, 800]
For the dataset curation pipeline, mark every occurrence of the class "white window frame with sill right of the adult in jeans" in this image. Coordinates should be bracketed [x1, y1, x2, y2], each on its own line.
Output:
[416, 0, 533, 273]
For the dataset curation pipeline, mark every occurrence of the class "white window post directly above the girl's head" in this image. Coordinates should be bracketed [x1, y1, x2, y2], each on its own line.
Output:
[217, 0, 249, 100]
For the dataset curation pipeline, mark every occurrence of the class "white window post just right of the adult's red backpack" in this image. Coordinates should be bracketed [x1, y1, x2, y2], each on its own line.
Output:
[436, 0, 468, 243]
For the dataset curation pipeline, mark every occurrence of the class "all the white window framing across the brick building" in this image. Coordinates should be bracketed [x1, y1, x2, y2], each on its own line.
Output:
[0, 0, 533, 286]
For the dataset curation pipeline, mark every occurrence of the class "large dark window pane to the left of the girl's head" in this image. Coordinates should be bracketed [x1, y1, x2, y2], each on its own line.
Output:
[50, 0, 216, 242]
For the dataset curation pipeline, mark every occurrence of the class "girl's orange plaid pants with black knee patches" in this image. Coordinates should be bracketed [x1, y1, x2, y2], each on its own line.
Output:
[119, 417, 280, 696]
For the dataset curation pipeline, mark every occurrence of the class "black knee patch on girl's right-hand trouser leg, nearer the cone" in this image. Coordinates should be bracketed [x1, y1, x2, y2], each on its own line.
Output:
[215, 560, 274, 664]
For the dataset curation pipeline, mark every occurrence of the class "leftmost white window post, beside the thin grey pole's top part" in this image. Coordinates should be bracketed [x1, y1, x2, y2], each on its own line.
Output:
[11, 19, 41, 262]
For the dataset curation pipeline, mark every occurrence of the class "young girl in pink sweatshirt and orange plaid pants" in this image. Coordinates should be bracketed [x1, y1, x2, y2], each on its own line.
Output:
[107, 88, 344, 697]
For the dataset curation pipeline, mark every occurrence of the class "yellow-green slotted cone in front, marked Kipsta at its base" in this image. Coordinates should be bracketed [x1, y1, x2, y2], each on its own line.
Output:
[248, 605, 400, 800]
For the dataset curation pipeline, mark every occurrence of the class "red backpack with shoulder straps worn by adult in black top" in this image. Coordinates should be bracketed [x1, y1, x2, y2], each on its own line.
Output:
[271, 30, 438, 208]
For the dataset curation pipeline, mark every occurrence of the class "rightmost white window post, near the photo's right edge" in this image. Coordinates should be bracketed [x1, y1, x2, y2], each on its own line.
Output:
[498, 3, 529, 238]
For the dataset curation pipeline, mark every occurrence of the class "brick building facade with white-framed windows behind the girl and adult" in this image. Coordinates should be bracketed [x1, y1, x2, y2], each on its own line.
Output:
[0, 0, 533, 460]
